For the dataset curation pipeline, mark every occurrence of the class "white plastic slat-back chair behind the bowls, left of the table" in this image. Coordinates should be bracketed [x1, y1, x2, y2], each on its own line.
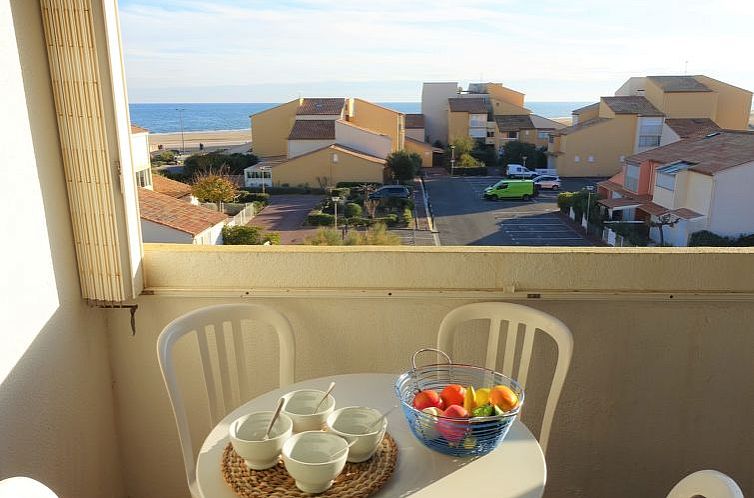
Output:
[157, 304, 295, 497]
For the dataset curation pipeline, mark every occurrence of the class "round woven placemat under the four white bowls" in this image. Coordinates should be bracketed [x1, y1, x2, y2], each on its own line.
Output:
[221, 433, 398, 498]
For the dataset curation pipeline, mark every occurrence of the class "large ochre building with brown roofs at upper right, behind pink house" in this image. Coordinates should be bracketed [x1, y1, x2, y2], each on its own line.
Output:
[548, 75, 752, 177]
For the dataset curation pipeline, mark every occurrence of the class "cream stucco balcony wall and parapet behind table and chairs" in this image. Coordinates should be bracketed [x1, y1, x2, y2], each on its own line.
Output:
[0, 0, 754, 498]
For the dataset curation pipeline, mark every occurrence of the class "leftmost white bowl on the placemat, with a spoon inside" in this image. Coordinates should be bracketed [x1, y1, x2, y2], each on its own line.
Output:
[229, 412, 293, 470]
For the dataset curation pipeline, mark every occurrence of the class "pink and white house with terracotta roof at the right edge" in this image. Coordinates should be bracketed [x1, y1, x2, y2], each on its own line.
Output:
[599, 130, 754, 246]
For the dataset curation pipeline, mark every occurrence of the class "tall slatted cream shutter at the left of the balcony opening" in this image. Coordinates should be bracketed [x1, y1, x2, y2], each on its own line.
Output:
[41, 0, 143, 302]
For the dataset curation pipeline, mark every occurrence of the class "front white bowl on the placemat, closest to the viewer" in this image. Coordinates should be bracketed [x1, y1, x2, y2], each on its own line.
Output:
[283, 431, 348, 493]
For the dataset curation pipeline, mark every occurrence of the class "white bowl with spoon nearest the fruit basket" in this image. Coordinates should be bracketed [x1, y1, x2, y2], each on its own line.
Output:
[326, 406, 387, 462]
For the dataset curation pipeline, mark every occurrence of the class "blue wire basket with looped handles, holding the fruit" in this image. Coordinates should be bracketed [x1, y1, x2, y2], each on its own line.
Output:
[395, 348, 524, 457]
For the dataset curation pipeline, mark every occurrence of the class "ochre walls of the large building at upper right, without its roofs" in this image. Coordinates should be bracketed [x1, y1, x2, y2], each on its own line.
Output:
[548, 76, 752, 176]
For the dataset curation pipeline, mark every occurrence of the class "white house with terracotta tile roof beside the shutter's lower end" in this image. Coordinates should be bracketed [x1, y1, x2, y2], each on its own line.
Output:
[139, 188, 228, 245]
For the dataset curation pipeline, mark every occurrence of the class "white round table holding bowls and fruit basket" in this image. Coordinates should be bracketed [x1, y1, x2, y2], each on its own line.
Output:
[196, 374, 547, 498]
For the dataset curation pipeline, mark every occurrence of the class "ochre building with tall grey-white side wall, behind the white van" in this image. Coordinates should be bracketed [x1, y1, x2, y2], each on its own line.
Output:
[422, 83, 565, 150]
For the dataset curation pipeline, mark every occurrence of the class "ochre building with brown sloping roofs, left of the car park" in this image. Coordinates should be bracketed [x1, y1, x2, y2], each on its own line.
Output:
[244, 98, 406, 187]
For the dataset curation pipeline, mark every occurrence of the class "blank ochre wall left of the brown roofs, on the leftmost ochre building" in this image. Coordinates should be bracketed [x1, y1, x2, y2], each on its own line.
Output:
[251, 99, 299, 157]
